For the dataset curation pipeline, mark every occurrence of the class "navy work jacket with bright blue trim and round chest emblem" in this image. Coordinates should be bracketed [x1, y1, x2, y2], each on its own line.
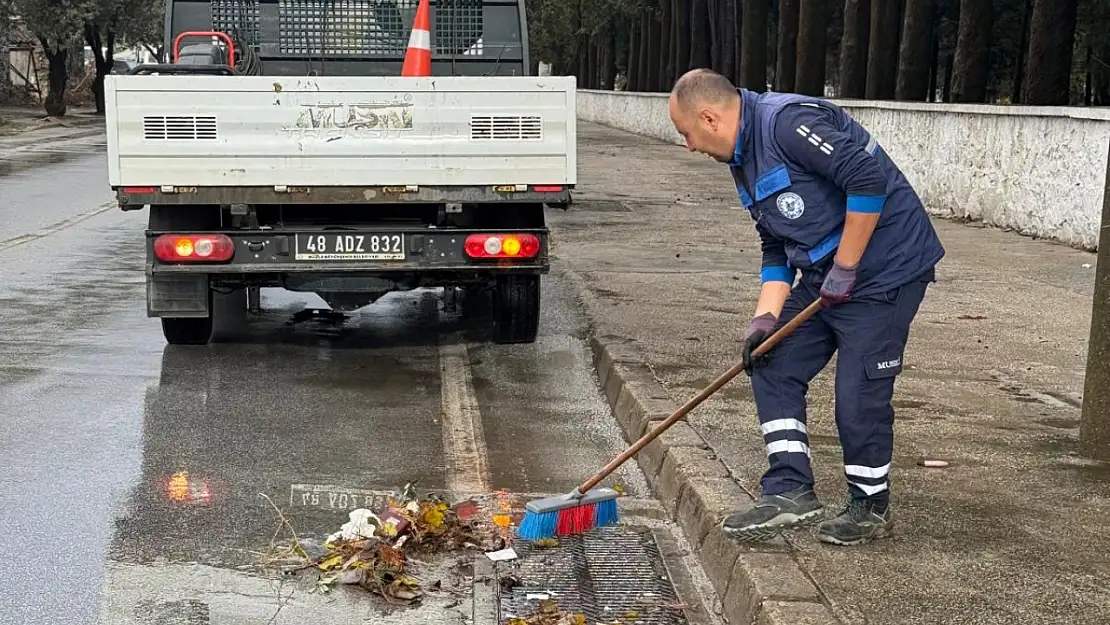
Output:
[728, 89, 945, 298]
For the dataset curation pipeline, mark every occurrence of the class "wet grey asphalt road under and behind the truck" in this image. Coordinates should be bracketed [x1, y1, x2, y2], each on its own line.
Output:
[0, 143, 646, 625]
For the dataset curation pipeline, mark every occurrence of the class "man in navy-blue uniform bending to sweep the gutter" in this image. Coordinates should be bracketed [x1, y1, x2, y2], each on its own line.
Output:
[669, 70, 945, 545]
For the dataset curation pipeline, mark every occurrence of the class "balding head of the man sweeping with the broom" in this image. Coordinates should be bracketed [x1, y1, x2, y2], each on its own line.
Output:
[668, 69, 741, 162]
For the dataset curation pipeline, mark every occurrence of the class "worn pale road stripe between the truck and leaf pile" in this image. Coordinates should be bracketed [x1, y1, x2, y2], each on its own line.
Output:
[440, 335, 491, 495]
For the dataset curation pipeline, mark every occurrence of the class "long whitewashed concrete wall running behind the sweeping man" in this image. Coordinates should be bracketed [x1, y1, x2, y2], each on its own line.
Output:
[577, 90, 1110, 250]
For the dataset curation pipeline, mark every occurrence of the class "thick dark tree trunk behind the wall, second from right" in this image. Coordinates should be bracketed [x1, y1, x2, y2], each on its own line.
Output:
[951, 0, 994, 102]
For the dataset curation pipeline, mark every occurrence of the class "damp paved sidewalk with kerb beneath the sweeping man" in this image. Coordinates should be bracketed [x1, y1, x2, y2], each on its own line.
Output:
[549, 122, 1110, 625]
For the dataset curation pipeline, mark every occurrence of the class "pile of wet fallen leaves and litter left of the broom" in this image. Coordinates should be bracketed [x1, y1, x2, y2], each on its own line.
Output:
[304, 484, 492, 604]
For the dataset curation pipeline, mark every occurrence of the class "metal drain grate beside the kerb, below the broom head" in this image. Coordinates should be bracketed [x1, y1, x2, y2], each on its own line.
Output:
[498, 525, 687, 625]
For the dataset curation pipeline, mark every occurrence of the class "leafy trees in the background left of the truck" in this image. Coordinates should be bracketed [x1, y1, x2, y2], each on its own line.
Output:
[0, 0, 164, 115]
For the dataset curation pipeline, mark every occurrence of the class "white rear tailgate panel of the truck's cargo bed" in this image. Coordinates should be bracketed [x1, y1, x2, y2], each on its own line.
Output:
[104, 74, 577, 188]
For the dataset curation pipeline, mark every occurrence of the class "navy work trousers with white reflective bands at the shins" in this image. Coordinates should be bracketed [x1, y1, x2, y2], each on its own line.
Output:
[751, 270, 934, 501]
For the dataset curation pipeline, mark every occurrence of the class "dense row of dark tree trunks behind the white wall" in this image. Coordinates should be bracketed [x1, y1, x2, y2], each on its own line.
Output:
[528, 0, 1110, 105]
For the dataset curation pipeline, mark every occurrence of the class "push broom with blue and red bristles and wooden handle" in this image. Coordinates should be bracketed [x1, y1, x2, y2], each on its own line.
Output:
[517, 298, 824, 541]
